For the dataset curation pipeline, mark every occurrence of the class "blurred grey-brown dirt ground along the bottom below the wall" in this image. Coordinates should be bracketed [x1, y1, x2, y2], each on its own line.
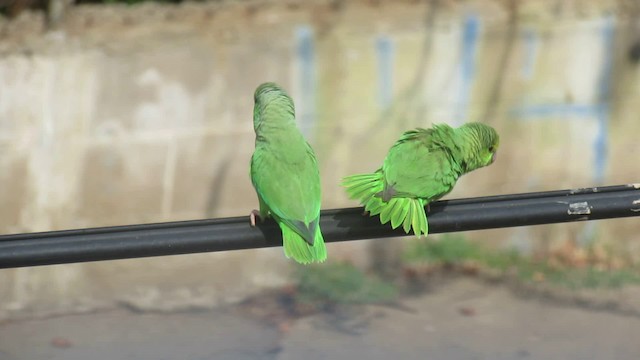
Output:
[0, 278, 640, 360]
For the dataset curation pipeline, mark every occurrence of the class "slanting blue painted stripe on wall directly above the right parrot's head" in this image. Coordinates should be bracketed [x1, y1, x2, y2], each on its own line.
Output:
[454, 15, 480, 123]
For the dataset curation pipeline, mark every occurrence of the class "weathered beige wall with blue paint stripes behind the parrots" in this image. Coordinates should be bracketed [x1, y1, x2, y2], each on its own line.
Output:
[0, 0, 640, 318]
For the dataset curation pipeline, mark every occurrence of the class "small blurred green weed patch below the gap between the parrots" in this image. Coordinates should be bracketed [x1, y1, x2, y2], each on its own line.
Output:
[297, 263, 397, 304]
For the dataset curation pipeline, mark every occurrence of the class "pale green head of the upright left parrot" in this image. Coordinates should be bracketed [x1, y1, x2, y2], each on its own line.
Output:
[253, 82, 295, 130]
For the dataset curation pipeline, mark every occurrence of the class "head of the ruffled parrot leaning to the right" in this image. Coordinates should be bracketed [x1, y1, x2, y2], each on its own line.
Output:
[460, 122, 500, 170]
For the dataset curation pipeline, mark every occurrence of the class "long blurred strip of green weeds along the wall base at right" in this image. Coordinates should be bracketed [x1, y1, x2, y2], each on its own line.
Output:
[404, 235, 640, 289]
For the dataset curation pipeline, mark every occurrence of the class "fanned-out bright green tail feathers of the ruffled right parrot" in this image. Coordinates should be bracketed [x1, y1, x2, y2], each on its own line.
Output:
[342, 172, 429, 237]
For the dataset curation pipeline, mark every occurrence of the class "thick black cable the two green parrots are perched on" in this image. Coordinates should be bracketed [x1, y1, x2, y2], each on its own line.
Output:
[0, 185, 640, 268]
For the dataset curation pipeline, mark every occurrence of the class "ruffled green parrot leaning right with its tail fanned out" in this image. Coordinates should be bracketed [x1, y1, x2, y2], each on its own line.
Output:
[342, 122, 500, 237]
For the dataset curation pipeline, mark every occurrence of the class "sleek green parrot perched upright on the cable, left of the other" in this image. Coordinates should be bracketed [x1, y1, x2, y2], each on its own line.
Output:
[250, 83, 327, 264]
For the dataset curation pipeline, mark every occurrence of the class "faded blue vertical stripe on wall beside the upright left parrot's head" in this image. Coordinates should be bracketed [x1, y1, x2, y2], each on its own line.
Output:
[295, 26, 316, 139]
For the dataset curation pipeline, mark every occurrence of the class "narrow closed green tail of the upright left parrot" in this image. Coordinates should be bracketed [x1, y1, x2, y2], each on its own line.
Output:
[280, 223, 327, 264]
